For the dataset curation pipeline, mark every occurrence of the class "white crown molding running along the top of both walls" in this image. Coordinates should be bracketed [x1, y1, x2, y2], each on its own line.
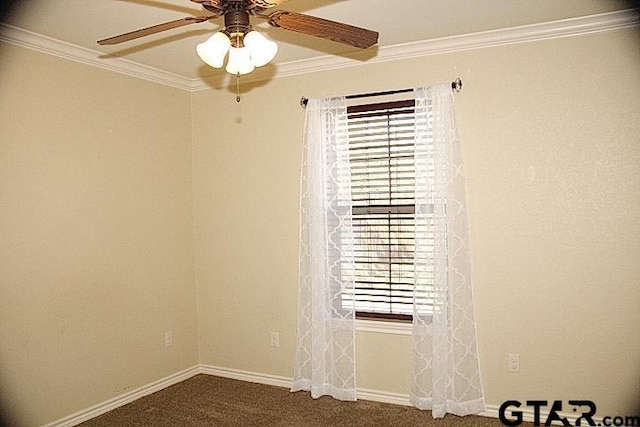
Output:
[0, 9, 640, 91]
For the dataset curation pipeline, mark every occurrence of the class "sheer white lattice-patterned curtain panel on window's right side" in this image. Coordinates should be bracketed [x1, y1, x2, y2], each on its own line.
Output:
[410, 85, 485, 418]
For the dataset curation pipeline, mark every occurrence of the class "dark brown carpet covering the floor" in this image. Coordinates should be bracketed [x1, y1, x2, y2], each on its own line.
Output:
[80, 375, 532, 427]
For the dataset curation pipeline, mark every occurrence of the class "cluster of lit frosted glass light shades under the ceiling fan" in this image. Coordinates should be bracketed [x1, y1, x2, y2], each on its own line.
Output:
[196, 30, 278, 75]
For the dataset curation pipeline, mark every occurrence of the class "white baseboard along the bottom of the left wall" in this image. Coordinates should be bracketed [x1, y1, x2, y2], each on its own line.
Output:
[42, 366, 201, 427]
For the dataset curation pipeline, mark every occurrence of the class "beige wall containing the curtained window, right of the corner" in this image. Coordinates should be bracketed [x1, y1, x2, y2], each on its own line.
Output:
[192, 29, 640, 416]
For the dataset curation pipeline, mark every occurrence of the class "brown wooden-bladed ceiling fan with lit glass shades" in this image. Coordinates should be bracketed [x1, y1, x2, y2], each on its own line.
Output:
[98, 0, 378, 76]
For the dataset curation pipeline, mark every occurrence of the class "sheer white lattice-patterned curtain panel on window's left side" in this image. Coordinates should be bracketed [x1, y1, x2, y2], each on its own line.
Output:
[292, 98, 356, 400]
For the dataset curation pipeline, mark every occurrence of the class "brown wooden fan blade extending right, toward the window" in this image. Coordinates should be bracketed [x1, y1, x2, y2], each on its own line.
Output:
[268, 10, 378, 49]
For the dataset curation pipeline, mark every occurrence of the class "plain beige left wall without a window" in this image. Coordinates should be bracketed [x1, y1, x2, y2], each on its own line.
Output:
[0, 44, 198, 426]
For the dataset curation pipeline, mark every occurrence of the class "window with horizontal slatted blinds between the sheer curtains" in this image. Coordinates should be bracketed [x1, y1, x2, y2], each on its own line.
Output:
[343, 100, 430, 321]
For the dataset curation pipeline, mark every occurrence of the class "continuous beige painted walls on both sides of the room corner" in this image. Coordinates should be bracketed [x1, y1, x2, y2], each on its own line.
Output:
[0, 24, 640, 425]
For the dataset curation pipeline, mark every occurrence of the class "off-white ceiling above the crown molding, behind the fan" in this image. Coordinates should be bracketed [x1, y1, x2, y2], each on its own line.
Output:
[4, 0, 634, 80]
